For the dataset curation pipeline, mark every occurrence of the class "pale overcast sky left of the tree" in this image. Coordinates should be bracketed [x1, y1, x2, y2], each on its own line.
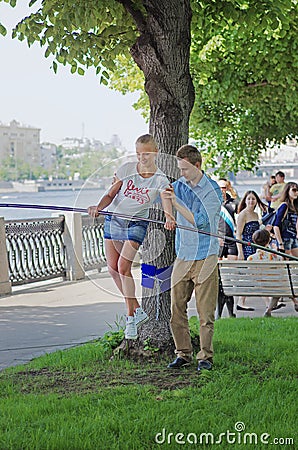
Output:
[0, 0, 148, 151]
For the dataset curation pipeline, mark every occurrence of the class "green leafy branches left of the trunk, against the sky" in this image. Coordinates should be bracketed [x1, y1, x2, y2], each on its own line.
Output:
[9, 0, 136, 79]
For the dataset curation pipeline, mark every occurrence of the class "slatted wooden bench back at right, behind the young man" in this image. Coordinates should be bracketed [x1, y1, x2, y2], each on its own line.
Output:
[218, 260, 298, 297]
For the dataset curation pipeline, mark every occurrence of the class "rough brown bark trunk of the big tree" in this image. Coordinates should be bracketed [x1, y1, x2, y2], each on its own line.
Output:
[127, 0, 194, 351]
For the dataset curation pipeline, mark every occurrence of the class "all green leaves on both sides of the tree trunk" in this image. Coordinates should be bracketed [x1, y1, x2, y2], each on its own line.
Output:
[0, 0, 298, 173]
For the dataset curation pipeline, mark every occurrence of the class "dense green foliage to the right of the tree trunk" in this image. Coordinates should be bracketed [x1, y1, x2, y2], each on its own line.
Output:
[190, 0, 298, 173]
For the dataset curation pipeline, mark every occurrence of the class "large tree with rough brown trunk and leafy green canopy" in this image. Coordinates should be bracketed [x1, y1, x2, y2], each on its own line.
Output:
[0, 0, 297, 347]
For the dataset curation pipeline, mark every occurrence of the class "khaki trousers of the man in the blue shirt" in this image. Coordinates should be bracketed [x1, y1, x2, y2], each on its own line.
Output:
[171, 255, 218, 362]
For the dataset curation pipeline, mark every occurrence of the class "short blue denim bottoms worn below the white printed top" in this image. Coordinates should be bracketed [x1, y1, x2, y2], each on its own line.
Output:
[104, 216, 149, 244]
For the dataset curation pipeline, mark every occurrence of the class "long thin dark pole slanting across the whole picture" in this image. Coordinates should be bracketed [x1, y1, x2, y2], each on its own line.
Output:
[0, 203, 298, 261]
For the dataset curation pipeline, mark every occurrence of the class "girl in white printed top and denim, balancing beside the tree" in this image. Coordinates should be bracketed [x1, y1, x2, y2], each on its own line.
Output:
[88, 134, 176, 339]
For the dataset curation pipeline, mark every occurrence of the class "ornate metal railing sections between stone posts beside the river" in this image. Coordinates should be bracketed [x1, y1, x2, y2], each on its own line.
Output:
[5, 215, 106, 286]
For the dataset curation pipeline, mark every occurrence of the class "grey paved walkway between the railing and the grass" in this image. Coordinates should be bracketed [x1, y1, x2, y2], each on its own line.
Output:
[0, 269, 298, 370]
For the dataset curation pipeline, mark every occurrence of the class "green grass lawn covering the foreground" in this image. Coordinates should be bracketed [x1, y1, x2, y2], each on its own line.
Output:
[0, 317, 298, 450]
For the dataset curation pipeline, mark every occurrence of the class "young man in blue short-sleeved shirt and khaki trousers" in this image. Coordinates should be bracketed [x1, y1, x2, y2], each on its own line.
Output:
[162, 144, 222, 372]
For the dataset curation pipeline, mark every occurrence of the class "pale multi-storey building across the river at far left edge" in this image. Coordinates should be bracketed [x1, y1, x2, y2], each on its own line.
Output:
[0, 120, 40, 166]
